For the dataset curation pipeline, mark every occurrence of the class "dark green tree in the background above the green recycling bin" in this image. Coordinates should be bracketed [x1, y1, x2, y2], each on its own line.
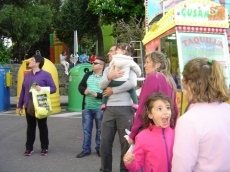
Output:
[54, 0, 103, 55]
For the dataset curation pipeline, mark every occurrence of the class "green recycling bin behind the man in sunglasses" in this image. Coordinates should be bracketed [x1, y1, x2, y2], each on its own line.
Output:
[66, 63, 92, 112]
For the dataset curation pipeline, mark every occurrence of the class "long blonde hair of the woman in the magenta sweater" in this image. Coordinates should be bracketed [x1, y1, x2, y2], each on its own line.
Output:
[146, 51, 176, 91]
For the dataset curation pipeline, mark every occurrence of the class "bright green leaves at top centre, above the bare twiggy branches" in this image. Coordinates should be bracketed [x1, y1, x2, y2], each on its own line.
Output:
[88, 0, 145, 24]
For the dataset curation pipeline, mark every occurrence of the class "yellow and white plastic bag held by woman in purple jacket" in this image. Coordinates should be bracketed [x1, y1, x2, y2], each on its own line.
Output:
[32, 87, 52, 119]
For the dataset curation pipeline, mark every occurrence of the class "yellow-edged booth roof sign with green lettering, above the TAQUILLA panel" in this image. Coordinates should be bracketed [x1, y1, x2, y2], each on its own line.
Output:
[143, 0, 229, 45]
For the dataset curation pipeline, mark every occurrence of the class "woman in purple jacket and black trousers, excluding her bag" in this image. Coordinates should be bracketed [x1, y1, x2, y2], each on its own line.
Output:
[18, 55, 56, 156]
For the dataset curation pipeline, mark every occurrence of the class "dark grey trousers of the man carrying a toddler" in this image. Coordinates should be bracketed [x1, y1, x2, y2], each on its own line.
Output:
[100, 106, 134, 172]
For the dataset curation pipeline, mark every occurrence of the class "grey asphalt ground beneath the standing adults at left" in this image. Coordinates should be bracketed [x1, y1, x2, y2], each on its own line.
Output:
[0, 107, 120, 172]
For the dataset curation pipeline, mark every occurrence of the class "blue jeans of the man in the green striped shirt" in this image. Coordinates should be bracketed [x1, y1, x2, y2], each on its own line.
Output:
[82, 109, 103, 153]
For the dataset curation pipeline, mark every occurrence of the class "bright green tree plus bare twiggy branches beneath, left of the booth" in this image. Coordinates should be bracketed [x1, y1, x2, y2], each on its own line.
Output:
[88, 0, 145, 47]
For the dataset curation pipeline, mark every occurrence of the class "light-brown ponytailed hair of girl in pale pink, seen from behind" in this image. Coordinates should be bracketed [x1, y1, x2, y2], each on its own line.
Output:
[182, 58, 230, 103]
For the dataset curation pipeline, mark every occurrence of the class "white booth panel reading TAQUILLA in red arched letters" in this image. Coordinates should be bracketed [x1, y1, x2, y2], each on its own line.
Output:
[177, 32, 230, 87]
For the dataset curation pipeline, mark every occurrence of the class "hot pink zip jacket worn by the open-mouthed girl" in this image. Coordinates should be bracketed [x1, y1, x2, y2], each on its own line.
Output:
[125, 125, 174, 172]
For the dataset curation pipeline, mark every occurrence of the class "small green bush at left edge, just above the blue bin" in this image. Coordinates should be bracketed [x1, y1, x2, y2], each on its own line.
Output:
[0, 39, 12, 64]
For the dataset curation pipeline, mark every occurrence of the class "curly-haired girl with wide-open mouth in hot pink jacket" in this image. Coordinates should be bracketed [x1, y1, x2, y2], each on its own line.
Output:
[123, 92, 174, 172]
